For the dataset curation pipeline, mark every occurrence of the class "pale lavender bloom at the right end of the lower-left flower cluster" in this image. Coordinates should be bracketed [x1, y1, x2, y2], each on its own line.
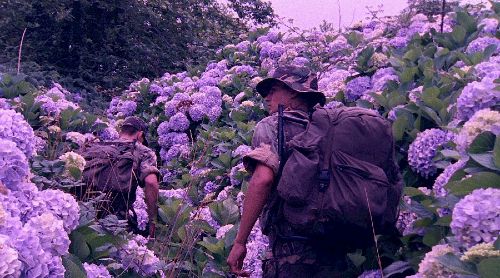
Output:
[40, 189, 80, 233]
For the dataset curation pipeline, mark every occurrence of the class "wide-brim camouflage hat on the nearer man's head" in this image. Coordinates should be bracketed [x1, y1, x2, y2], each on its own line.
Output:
[255, 66, 326, 106]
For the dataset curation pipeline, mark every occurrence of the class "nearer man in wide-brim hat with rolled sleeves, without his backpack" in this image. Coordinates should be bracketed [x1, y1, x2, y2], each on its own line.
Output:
[227, 66, 348, 277]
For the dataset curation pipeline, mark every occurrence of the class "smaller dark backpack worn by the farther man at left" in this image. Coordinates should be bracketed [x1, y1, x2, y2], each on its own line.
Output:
[82, 142, 139, 213]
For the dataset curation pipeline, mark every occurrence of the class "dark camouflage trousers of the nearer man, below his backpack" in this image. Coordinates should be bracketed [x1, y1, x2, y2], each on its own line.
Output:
[262, 233, 347, 278]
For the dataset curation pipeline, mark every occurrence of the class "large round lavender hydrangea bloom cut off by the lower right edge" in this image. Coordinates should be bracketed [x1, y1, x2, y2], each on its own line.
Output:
[450, 188, 500, 247]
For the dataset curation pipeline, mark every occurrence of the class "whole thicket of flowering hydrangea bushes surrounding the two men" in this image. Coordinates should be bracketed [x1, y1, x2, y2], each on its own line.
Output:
[0, 3, 500, 277]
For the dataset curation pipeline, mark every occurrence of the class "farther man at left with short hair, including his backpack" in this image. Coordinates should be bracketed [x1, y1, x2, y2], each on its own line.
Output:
[82, 117, 160, 237]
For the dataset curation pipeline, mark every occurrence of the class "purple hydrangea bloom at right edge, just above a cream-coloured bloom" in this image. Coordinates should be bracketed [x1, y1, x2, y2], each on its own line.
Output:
[457, 78, 500, 121]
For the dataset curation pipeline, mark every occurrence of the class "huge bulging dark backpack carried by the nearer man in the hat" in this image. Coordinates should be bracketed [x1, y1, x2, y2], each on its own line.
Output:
[277, 107, 402, 242]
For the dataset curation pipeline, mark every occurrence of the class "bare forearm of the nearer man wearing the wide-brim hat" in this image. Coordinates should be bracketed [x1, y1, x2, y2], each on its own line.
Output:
[235, 165, 273, 244]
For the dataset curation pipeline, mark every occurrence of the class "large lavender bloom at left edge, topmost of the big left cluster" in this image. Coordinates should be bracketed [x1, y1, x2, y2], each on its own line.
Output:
[0, 109, 36, 158]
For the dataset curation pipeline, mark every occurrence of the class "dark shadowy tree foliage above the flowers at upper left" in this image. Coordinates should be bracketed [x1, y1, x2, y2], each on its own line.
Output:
[0, 0, 274, 92]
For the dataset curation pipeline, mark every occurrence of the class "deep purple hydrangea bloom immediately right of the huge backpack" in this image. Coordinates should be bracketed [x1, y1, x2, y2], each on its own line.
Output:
[408, 128, 454, 178]
